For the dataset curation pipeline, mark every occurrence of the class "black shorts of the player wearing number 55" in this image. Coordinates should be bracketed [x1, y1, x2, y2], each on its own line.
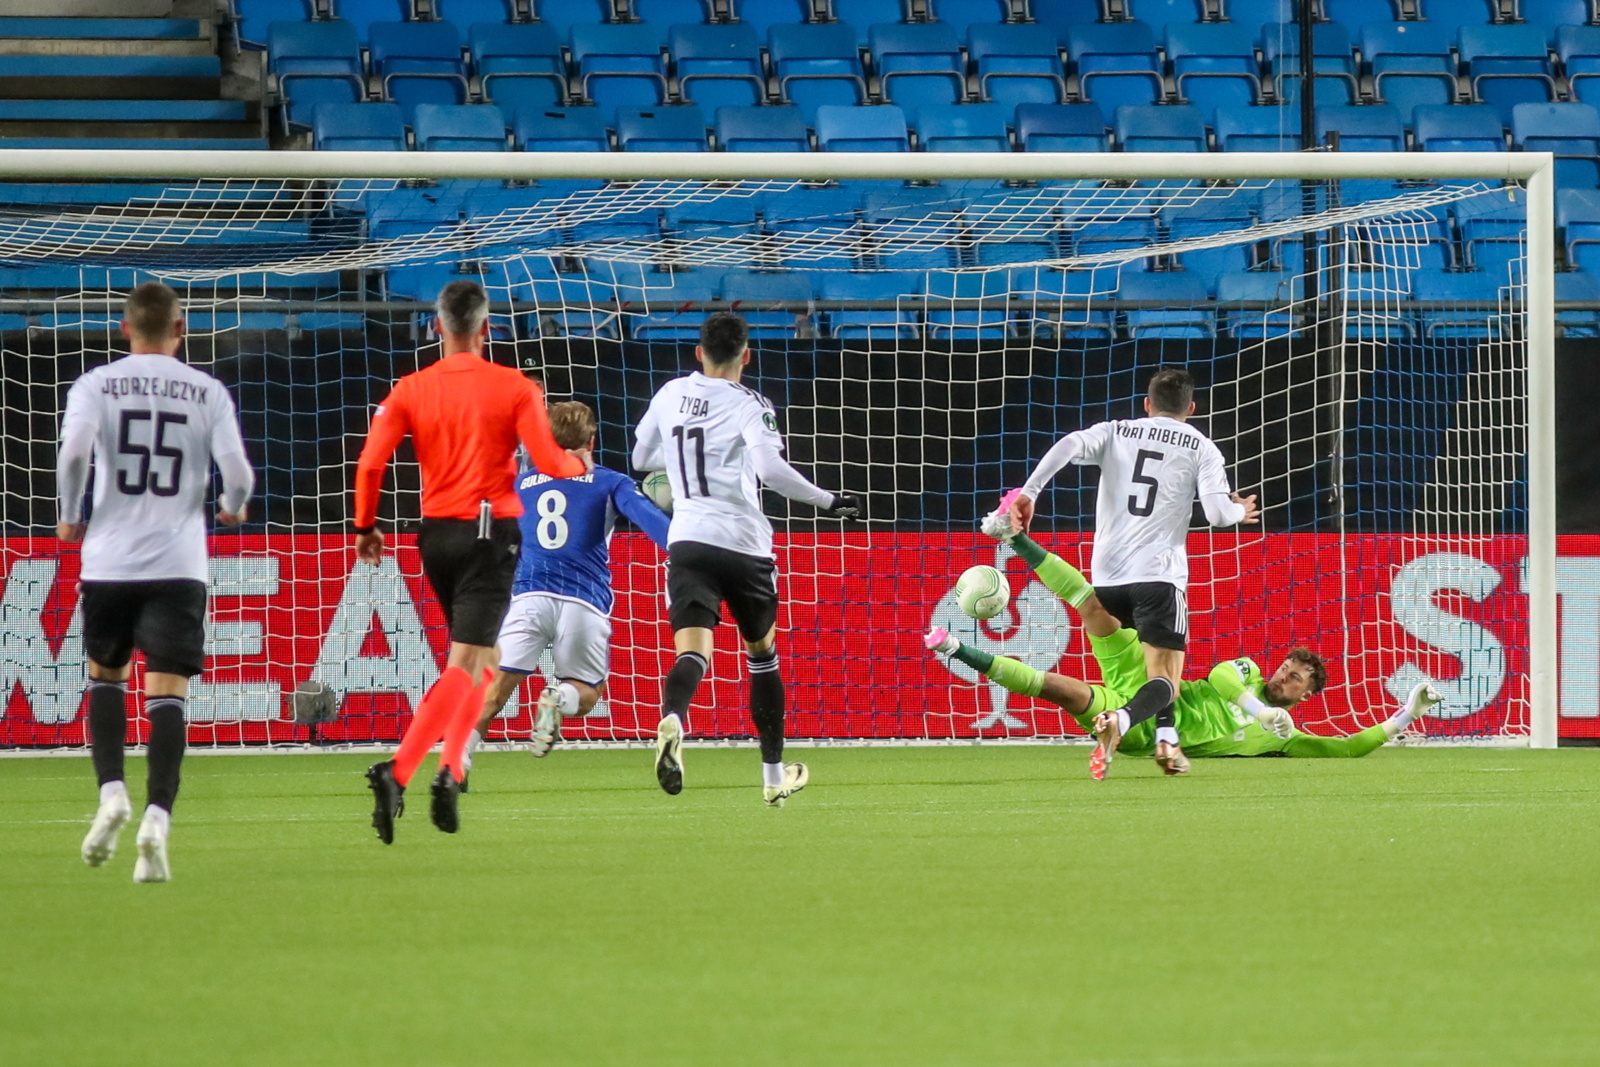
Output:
[78, 579, 205, 678]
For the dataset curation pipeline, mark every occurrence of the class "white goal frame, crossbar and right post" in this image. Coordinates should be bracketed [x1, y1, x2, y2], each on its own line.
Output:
[0, 149, 1558, 749]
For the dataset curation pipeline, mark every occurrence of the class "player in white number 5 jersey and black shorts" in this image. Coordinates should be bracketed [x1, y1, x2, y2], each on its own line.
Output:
[982, 368, 1258, 777]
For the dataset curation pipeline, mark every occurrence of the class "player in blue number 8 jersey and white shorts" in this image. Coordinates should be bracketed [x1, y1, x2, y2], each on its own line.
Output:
[467, 400, 667, 763]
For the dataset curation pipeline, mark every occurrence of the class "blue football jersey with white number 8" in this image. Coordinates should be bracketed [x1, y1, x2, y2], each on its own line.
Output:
[512, 467, 669, 614]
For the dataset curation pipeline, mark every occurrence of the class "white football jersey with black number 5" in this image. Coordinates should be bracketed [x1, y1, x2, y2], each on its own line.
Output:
[1072, 416, 1232, 589]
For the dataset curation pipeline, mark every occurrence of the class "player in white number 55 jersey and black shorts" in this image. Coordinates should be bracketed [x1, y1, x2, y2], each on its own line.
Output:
[56, 282, 254, 881]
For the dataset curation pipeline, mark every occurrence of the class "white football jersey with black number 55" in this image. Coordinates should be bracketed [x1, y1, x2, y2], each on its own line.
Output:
[61, 355, 245, 582]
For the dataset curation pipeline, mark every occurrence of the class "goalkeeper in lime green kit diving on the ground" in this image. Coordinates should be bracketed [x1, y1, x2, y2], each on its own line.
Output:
[923, 534, 1440, 779]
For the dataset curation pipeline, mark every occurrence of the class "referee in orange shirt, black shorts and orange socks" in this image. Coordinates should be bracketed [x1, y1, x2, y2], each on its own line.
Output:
[355, 282, 587, 845]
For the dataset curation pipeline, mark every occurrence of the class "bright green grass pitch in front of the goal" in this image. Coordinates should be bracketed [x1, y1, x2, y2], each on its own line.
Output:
[0, 747, 1600, 1067]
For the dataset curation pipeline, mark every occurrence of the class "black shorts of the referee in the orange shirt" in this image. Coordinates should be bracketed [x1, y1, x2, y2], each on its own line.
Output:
[416, 518, 522, 648]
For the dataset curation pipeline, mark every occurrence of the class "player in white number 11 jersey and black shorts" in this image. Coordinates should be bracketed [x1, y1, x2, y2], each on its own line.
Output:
[634, 314, 861, 808]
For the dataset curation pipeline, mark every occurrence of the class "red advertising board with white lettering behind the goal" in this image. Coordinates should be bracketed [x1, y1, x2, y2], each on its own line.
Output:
[0, 533, 1600, 745]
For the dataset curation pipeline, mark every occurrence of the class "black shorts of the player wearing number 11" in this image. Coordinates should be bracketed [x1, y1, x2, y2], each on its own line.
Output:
[667, 541, 778, 641]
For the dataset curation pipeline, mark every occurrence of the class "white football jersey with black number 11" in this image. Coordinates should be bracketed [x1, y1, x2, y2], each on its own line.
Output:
[635, 371, 784, 558]
